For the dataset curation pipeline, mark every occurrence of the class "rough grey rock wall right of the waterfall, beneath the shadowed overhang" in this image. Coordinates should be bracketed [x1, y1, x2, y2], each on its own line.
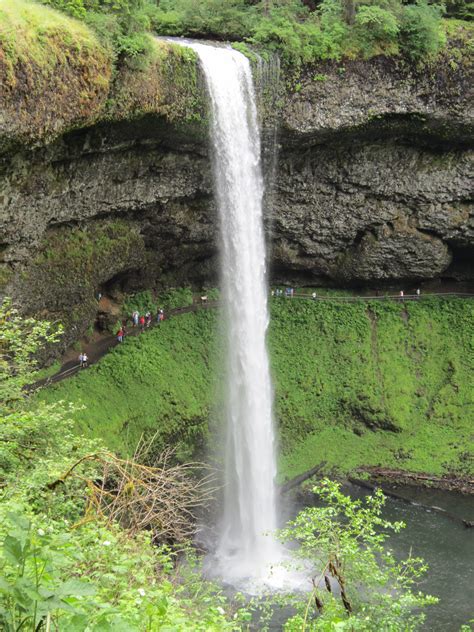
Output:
[273, 139, 474, 284]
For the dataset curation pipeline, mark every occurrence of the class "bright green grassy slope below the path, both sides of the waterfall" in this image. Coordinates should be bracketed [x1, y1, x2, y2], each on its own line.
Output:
[41, 298, 474, 478]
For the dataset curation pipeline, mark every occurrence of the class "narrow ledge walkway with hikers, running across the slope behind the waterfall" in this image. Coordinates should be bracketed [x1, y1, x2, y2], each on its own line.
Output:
[32, 292, 474, 390]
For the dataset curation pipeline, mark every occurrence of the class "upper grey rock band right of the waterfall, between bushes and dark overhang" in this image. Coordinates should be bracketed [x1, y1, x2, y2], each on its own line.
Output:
[281, 57, 474, 146]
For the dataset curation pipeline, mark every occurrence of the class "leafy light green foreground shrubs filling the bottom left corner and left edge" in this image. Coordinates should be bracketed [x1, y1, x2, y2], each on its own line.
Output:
[0, 302, 249, 632]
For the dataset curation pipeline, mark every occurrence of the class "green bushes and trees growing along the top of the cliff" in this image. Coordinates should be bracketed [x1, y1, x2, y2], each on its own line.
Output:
[33, 0, 466, 65]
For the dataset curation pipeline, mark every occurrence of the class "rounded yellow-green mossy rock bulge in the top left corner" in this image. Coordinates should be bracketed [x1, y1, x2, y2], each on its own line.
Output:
[0, 0, 112, 151]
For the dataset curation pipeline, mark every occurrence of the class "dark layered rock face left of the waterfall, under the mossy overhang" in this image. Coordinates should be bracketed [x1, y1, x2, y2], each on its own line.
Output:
[1, 125, 216, 346]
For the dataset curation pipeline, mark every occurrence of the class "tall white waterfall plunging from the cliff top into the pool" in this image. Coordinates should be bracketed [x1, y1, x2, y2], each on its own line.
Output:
[182, 41, 280, 579]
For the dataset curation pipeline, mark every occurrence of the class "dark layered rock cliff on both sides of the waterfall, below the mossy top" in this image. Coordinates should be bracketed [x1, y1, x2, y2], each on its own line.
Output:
[0, 45, 474, 344]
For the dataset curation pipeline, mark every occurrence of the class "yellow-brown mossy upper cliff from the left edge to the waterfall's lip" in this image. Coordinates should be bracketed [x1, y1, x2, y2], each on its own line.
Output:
[0, 0, 203, 154]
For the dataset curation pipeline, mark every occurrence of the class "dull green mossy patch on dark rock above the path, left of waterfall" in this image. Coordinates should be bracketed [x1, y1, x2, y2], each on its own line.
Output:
[15, 220, 145, 348]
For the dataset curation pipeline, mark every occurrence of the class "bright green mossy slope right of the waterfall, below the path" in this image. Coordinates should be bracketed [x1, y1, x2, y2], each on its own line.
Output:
[270, 299, 474, 475]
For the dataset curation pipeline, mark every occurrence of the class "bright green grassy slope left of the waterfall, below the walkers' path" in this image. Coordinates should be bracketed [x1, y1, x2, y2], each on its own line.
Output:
[41, 312, 215, 458]
